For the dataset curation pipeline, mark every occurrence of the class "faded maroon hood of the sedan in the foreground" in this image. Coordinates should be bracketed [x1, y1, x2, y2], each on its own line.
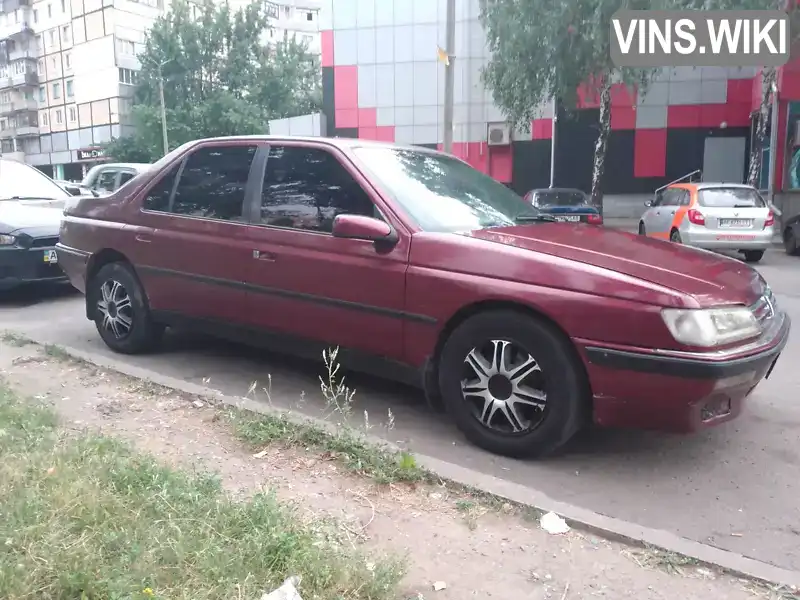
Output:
[465, 223, 764, 306]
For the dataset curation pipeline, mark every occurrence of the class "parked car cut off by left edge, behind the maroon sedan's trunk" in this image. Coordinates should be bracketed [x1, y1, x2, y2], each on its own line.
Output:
[0, 158, 71, 291]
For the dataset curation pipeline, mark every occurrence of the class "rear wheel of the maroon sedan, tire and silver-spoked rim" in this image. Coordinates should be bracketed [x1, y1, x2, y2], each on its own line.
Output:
[86, 262, 164, 354]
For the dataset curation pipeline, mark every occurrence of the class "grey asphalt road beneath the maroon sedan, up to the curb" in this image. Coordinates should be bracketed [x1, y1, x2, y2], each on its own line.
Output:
[0, 249, 800, 570]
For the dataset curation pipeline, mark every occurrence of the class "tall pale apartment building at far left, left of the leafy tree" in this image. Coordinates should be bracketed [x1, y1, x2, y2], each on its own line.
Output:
[0, 0, 164, 179]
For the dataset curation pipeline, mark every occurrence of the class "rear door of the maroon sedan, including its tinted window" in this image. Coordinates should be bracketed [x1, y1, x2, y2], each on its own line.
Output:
[130, 142, 260, 327]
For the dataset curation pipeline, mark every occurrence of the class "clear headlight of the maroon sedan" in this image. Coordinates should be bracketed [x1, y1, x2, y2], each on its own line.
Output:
[661, 306, 761, 348]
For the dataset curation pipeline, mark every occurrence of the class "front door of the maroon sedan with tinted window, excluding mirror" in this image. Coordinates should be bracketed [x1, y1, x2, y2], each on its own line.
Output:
[239, 142, 409, 359]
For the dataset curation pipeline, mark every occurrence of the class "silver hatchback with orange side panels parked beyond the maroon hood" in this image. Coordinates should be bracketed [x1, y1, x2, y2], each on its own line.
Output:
[639, 183, 775, 262]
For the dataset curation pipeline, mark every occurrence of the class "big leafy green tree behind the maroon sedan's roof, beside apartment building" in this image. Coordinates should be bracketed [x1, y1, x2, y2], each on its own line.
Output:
[106, 0, 321, 161]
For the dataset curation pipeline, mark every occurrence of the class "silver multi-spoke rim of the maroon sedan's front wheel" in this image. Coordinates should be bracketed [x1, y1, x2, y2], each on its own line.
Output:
[461, 340, 547, 434]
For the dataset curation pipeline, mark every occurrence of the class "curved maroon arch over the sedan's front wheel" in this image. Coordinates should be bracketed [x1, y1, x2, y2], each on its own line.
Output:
[423, 300, 592, 412]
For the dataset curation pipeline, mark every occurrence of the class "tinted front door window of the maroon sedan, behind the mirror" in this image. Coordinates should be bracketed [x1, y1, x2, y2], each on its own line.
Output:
[260, 146, 383, 233]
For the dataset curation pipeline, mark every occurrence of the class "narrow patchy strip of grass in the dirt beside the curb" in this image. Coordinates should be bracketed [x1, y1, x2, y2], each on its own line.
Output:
[225, 409, 424, 484]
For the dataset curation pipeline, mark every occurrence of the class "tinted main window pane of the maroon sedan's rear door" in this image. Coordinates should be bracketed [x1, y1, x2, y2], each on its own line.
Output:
[170, 146, 258, 221]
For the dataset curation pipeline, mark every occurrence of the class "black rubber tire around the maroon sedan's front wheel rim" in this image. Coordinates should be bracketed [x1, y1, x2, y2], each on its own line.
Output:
[439, 310, 591, 458]
